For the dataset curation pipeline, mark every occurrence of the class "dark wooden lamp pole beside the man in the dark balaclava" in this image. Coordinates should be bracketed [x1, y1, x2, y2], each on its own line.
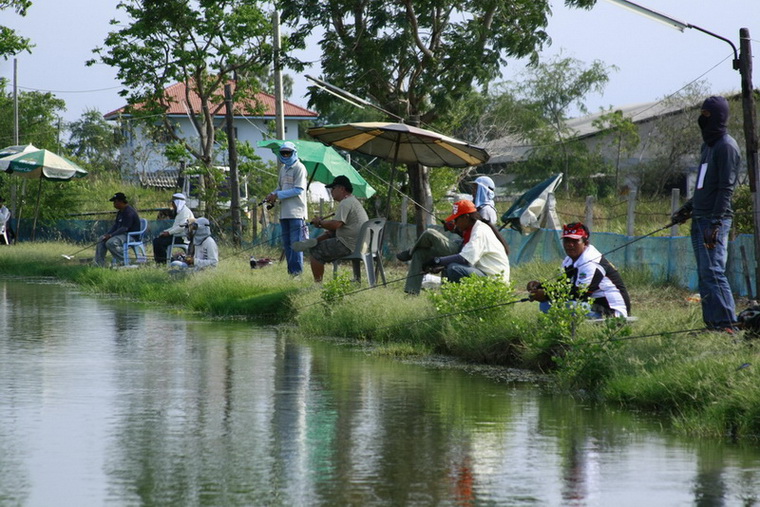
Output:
[739, 28, 760, 296]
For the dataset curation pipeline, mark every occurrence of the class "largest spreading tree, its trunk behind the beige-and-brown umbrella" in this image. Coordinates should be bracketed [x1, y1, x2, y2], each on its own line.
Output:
[280, 0, 594, 231]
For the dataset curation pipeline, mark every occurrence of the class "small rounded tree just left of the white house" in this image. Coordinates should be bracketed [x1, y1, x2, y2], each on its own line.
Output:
[66, 109, 119, 172]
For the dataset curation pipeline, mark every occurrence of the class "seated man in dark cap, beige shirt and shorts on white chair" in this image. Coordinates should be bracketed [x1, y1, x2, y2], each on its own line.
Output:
[293, 176, 369, 282]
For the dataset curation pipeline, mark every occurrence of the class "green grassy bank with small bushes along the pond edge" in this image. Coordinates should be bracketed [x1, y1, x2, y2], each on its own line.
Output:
[0, 243, 760, 438]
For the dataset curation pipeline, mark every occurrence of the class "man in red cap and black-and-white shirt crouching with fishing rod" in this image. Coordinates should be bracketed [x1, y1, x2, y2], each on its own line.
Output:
[528, 222, 631, 318]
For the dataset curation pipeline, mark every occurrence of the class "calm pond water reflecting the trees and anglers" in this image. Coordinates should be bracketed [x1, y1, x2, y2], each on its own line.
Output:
[0, 279, 760, 507]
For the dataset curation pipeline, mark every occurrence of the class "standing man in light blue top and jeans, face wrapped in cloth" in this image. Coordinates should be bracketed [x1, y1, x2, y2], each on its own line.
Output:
[266, 141, 309, 276]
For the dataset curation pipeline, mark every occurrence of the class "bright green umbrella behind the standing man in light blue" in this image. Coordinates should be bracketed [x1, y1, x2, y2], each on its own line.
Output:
[257, 139, 375, 197]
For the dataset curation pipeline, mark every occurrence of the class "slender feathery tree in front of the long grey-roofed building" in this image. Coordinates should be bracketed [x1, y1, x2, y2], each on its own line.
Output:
[508, 55, 615, 191]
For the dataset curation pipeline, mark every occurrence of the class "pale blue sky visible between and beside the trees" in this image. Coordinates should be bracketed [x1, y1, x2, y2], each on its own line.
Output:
[0, 0, 760, 127]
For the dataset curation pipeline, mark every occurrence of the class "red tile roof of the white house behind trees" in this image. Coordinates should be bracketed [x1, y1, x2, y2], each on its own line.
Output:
[104, 83, 318, 120]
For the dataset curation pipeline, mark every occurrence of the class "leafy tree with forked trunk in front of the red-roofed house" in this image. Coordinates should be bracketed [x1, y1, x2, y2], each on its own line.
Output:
[89, 0, 282, 216]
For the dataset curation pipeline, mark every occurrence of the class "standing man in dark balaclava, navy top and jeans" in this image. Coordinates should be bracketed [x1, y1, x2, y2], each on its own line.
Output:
[673, 97, 741, 333]
